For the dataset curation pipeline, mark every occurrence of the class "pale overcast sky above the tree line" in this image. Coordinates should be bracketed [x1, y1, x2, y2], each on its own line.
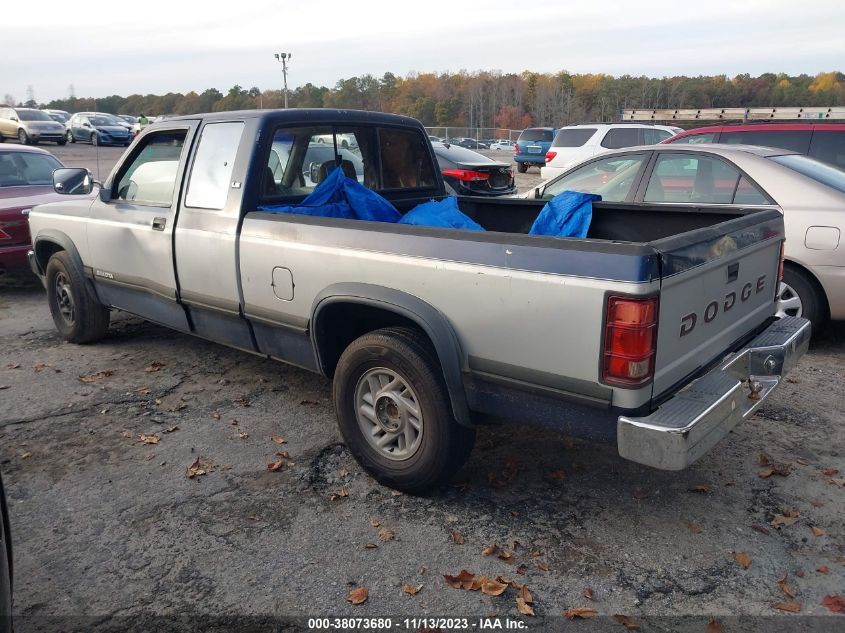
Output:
[0, 0, 845, 103]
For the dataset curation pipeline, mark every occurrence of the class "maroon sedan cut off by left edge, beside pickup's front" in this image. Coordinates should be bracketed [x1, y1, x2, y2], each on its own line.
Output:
[0, 144, 67, 274]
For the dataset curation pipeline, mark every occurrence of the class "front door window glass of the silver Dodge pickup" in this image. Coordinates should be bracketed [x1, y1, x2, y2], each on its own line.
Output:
[112, 130, 187, 207]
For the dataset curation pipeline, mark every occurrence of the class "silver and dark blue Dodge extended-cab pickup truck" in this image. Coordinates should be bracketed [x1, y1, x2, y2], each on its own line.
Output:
[29, 109, 810, 492]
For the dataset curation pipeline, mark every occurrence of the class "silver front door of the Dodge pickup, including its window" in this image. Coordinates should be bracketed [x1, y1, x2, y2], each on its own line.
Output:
[88, 121, 197, 331]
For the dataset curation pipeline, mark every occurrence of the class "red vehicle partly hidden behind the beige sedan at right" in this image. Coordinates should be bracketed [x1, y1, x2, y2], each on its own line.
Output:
[662, 123, 845, 169]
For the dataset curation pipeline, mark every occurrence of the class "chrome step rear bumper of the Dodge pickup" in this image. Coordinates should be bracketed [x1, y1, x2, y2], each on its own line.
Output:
[616, 317, 811, 470]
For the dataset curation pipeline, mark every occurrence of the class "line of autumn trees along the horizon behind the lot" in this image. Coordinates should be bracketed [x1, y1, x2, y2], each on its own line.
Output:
[27, 71, 845, 129]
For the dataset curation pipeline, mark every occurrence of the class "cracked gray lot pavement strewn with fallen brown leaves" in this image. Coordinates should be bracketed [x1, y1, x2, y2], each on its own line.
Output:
[0, 141, 845, 632]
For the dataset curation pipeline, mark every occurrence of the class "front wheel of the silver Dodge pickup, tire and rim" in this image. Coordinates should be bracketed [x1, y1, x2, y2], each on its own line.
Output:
[47, 251, 109, 343]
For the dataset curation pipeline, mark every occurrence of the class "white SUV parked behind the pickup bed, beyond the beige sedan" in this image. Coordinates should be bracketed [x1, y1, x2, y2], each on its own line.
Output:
[540, 123, 682, 180]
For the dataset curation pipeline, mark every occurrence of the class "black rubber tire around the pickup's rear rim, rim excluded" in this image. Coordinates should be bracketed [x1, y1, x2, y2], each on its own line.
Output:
[333, 327, 475, 494]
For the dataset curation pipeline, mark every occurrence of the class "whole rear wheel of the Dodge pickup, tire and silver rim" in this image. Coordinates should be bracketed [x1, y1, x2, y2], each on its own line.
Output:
[333, 327, 475, 493]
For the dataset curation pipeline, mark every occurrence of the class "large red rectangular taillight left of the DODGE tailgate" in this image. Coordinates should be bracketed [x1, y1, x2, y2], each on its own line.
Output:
[602, 297, 657, 387]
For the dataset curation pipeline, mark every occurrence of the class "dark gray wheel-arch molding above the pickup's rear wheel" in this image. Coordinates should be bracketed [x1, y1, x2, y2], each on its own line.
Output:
[311, 283, 474, 427]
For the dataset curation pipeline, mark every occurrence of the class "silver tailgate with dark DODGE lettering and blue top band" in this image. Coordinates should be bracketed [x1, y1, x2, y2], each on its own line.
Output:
[651, 210, 784, 398]
